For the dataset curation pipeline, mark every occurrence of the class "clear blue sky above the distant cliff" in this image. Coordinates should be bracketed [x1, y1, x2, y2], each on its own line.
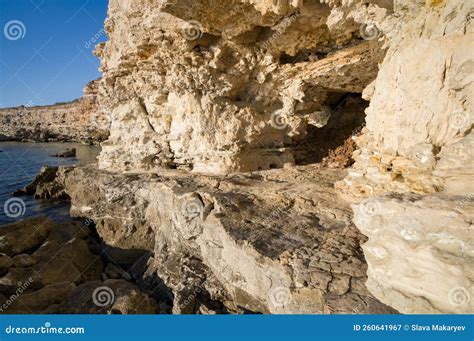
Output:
[0, 0, 107, 108]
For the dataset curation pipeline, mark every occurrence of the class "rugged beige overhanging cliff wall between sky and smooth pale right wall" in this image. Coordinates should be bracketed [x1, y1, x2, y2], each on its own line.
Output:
[96, 0, 388, 174]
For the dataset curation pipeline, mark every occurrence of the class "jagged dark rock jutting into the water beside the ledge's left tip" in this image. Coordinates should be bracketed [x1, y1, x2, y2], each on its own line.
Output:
[13, 166, 73, 200]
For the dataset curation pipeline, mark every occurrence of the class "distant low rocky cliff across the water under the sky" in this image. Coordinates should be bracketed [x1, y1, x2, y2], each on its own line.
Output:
[0, 81, 110, 144]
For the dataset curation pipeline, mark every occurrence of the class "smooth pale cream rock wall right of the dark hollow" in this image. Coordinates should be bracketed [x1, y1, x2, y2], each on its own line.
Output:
[338, 1, 474, 313]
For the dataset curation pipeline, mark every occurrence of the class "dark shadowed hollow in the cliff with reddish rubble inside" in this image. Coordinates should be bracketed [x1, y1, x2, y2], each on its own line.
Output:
[294, 93, 369, 168]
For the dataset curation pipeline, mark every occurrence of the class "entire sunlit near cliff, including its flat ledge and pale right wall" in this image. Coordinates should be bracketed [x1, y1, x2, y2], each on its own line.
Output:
[31, 0, 474, 313]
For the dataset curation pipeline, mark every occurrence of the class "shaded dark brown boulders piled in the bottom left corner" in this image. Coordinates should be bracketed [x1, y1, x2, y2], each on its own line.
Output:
[0, 218, 162, 314]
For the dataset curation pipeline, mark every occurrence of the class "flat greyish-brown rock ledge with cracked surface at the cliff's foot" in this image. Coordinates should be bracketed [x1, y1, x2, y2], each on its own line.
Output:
[64, 166, 396, 314]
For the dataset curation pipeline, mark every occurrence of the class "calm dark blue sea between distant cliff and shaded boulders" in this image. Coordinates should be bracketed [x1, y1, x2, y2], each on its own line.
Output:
[0, 142, 100, 226]
